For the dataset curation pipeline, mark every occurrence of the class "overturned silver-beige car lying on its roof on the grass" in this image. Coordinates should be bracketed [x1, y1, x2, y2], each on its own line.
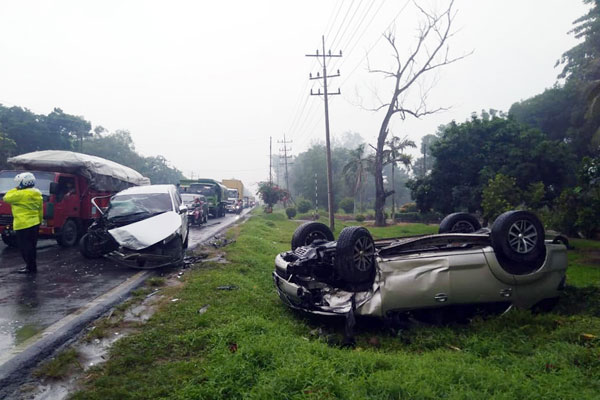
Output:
[273, 211, 567, 324]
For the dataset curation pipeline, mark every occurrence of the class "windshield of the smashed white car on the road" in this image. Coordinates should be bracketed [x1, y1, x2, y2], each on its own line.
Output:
[107, 193, 173, 219]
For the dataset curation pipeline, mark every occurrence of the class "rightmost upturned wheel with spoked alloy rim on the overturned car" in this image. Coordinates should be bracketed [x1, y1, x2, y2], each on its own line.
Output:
[490, 211, 546, 275]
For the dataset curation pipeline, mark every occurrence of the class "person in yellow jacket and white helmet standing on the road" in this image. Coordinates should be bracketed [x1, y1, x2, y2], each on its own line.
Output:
[3, 172, 44, 273]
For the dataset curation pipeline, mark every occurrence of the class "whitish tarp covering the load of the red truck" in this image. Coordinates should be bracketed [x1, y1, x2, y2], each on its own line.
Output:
[8, 150, 150, 192]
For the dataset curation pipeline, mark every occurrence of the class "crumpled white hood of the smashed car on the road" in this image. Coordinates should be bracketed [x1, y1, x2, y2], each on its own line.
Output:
[108, 211, 181, 250]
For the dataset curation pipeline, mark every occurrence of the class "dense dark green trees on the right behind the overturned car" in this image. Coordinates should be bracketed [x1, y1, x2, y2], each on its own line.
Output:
[407, 0, 600, 236]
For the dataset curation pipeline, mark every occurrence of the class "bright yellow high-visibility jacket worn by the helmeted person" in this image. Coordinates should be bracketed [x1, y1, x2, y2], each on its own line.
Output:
[3, 188, 44, 231]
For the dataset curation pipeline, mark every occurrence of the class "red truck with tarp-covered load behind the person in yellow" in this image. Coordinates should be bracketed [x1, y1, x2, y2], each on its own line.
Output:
[0, 150, 150, 247]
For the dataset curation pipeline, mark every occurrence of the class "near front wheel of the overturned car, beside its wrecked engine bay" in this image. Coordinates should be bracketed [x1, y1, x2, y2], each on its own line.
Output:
[334, 226, 375, 285]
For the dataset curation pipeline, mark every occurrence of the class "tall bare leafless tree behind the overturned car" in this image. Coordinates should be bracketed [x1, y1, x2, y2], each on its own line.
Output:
[369, 1, 470, 226]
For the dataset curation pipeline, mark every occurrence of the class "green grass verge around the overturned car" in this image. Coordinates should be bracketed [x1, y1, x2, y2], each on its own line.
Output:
[73, 213, 600, 400]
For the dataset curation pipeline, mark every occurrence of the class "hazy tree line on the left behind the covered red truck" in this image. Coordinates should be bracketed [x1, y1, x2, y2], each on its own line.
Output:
[0, 105, 183, 184]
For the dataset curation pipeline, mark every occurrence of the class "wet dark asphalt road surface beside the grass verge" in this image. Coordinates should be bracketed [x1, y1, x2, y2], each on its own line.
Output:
[0, 210, 247, 356]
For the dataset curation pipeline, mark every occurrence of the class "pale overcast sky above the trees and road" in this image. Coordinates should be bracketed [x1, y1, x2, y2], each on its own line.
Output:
[0, 0, 587, 192]
